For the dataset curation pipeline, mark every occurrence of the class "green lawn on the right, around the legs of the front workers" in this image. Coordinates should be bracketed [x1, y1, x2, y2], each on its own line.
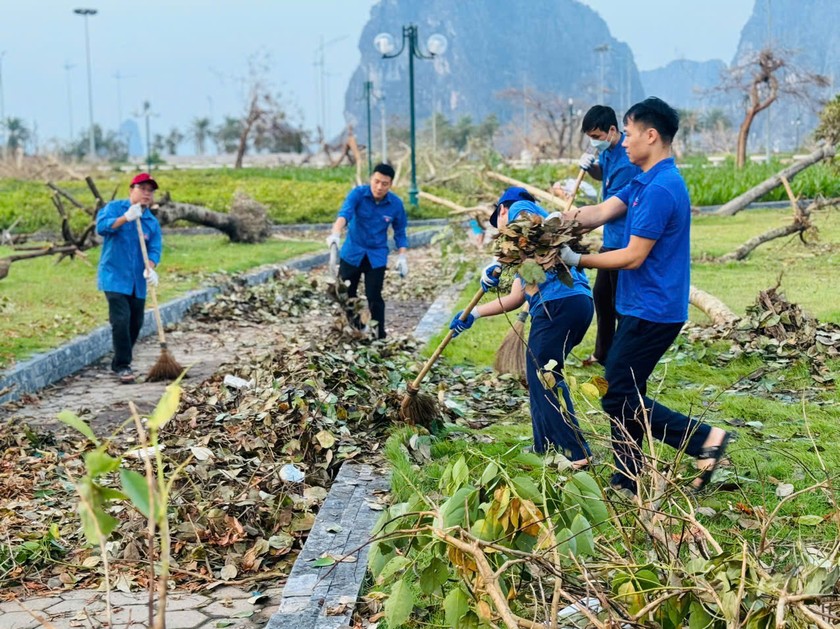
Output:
[404, 204, 840, 538]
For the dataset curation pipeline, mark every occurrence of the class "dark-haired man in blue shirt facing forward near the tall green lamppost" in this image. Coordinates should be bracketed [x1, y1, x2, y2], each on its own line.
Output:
[327, 164, 408, 339]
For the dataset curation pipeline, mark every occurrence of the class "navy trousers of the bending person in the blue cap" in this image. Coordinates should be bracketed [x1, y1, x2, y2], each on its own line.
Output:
[525, 295, 594, 461]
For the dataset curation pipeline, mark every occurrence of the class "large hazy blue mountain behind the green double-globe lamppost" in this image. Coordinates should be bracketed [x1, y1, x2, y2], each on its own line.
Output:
[344, 0, 643, 142]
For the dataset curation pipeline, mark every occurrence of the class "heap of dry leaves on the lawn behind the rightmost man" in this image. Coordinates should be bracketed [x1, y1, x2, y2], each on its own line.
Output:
[689, 285, 840, 386]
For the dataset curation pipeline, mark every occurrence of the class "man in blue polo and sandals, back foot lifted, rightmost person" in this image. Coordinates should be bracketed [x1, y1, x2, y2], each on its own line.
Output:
[561, 97, 730, 493]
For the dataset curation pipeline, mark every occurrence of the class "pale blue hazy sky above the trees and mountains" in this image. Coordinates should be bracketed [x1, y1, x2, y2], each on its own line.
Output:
[0, 0, 764, 152]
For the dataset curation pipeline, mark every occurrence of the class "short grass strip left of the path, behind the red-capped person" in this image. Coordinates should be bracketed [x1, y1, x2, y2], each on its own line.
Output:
[0, 234, 323, 368]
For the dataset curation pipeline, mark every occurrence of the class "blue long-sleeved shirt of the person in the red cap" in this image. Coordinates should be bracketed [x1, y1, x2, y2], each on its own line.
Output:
[96, 199, 163, 299]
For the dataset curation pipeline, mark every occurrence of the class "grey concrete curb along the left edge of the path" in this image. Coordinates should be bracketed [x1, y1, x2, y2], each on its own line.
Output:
[0, 229, 439, 404]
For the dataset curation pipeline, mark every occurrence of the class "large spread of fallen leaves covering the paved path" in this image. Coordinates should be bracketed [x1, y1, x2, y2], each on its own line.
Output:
[0, 264, 524, 592]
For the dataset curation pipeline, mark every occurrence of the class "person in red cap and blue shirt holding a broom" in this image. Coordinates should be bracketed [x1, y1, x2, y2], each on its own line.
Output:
[96, 173, 163, 384]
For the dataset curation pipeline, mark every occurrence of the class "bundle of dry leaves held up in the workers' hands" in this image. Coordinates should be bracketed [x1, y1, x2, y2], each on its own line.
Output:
[494, 212, 585, 286]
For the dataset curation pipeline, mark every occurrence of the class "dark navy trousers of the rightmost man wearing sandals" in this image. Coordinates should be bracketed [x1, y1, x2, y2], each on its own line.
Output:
[601, 316, 711, 492]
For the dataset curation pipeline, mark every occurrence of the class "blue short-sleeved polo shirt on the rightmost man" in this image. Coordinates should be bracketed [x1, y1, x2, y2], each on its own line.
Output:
[615, 158, 691, 323]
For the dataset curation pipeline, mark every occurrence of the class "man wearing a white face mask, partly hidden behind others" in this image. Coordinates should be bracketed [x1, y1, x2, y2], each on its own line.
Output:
[579, 105, 642, 365]
